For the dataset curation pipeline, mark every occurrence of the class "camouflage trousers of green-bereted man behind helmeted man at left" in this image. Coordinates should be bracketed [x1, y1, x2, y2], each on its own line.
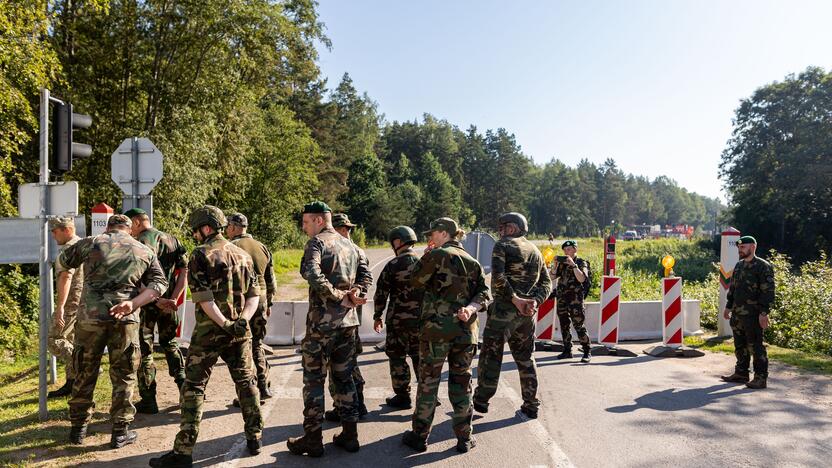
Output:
[139, 305, 185, 401]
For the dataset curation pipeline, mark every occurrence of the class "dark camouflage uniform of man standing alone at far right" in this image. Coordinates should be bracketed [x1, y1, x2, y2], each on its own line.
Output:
[726, 256, 774, 378]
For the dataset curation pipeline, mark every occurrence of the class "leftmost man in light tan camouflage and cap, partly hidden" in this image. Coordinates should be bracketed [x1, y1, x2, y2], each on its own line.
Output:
[47, 217, 84, 398]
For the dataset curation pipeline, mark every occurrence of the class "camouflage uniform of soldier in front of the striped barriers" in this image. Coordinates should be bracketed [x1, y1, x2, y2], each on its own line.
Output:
[554, 257, 590, 353]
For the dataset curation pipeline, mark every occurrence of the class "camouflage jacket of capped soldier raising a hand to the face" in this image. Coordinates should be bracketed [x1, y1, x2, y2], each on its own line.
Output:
[410, 240, 491, 344]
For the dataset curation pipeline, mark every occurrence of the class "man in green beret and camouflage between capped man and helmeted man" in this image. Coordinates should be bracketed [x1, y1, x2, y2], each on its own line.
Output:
[124, 208, 188, 414]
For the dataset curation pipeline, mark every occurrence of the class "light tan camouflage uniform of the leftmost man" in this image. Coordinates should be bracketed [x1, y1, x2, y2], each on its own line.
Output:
[48, 236, 84, 381]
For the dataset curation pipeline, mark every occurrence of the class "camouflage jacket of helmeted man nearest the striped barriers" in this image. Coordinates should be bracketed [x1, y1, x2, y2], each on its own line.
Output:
[491, 237, 552, 312]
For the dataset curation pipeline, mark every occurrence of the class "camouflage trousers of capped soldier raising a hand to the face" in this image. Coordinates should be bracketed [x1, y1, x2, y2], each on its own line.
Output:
[413, 340, 476, 440]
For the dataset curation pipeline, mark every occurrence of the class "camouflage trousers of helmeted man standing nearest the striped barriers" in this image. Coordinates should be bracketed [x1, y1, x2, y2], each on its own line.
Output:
[474, 310, 540, 411]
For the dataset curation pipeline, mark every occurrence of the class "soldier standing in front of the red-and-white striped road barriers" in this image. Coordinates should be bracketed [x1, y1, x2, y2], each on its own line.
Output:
[554, 240, 592, 362]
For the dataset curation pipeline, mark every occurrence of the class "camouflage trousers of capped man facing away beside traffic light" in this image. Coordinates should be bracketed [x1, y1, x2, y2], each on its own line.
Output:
[69, 320, 140, 428]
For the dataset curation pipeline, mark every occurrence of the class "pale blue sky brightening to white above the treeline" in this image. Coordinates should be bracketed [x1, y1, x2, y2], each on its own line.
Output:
[319, 0, 832, 200]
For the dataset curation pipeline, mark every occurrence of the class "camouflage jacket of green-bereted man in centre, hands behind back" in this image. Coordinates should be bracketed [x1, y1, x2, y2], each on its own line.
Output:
[300, 228, 372, 332]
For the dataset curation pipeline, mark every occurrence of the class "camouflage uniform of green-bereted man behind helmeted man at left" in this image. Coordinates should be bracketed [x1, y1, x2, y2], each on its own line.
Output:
[136, 227, 188, 402]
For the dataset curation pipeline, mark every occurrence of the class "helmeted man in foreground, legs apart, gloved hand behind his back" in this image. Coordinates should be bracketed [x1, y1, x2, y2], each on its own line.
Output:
[150, 205, 263, 467]
